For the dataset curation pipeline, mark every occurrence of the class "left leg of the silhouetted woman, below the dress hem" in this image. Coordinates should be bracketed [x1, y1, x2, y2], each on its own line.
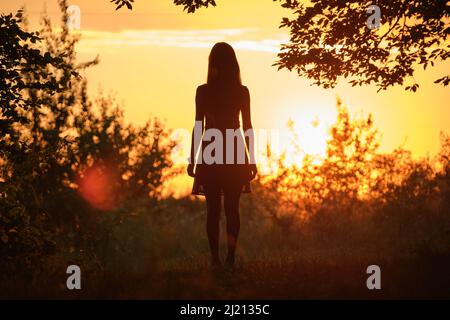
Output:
[205, 185, 221, 265]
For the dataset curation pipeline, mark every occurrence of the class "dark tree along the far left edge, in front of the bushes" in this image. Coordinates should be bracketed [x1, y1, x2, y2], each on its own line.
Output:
[0, 6, 78, 282]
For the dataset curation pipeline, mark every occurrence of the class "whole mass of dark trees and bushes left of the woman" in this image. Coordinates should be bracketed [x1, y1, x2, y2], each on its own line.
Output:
[0, 1, 175, 284]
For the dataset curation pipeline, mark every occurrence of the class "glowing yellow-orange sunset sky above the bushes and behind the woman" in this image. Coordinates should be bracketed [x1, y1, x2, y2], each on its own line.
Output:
[0, 0, 450, 194]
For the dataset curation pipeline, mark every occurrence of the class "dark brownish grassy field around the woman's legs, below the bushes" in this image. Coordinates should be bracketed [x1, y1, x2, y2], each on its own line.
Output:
[1, 192, 450, 299]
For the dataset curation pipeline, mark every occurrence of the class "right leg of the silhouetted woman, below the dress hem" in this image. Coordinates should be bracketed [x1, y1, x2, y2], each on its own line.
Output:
[224, 185, 242, 266]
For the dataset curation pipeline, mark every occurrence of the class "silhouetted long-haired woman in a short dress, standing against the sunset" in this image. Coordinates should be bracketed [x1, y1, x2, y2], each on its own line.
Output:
[188, 42, 257, 267]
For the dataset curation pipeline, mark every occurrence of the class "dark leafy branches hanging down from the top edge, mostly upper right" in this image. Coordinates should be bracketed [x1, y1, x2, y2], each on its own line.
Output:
[112, 0, 450, 92]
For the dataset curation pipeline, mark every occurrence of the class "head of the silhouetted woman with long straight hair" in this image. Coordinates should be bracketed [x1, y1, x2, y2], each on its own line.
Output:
[207, 42, 241, 84]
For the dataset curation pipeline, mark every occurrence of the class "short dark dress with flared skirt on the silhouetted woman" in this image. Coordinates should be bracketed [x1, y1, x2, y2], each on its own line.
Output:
[192, 84, 251, 195]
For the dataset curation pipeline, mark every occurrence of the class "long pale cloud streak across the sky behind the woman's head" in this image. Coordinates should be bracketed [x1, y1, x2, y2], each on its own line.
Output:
[75, 28, 287, 52]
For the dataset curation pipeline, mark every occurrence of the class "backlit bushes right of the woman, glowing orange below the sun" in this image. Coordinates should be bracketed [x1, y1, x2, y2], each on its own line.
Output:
[256, 101, 450, 257]
